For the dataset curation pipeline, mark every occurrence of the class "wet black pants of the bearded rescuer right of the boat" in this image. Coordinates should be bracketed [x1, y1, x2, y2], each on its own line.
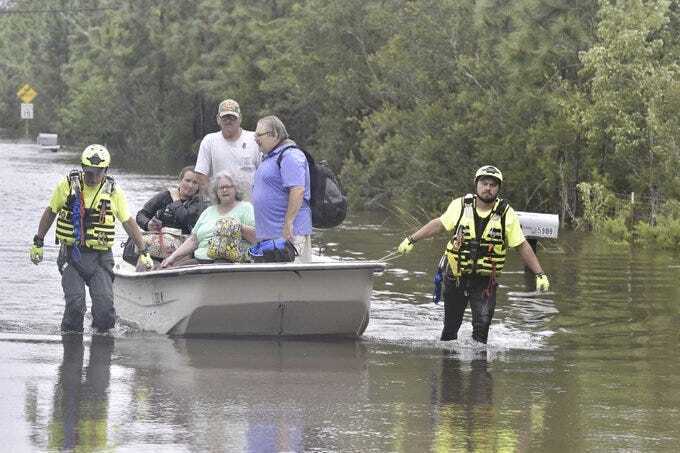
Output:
[441, 273, 498, 343]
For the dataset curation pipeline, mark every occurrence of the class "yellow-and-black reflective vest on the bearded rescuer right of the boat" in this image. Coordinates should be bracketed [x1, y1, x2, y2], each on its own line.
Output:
[445, 194, 509, 277]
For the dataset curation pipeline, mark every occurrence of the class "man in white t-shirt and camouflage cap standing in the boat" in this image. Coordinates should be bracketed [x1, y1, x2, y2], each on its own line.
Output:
[195, 99, 262, 200]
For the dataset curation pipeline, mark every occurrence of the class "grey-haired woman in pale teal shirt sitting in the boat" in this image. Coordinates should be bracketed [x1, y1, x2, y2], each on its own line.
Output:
[161, 172, 255, 267]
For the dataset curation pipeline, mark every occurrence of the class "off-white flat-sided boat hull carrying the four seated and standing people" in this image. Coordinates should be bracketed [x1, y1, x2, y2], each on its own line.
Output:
[113, 260, 385, 337]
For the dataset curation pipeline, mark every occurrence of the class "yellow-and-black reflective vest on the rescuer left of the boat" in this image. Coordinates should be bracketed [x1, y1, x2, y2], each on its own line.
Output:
[56, 170, 115, 251]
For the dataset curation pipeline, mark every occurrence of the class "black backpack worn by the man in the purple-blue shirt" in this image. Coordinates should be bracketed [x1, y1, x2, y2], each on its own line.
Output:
[276, 145, 347, 228]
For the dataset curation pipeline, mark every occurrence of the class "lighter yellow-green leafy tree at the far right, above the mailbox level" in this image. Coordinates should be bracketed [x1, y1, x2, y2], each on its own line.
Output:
[578, 0, 678, 198]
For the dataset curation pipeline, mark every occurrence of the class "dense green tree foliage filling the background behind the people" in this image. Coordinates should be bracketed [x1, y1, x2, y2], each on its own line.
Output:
[0, 0, 680, 221]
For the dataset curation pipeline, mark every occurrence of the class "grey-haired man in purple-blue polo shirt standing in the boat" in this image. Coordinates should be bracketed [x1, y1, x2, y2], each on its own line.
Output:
[252, 116, 312, 262]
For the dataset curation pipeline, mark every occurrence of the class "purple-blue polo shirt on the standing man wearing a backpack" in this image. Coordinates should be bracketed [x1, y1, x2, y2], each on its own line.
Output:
[251, 142, 312, 241]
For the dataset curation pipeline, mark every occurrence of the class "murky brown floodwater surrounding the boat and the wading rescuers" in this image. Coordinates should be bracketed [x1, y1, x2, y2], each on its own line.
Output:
[0, 143, 680, 452]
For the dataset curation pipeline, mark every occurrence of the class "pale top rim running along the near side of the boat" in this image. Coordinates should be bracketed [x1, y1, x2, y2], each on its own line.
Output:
[113, 261, 386, 279]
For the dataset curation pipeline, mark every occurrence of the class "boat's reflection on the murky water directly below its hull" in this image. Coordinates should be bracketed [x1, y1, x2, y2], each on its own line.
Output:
[117, 338, 368, 452]
